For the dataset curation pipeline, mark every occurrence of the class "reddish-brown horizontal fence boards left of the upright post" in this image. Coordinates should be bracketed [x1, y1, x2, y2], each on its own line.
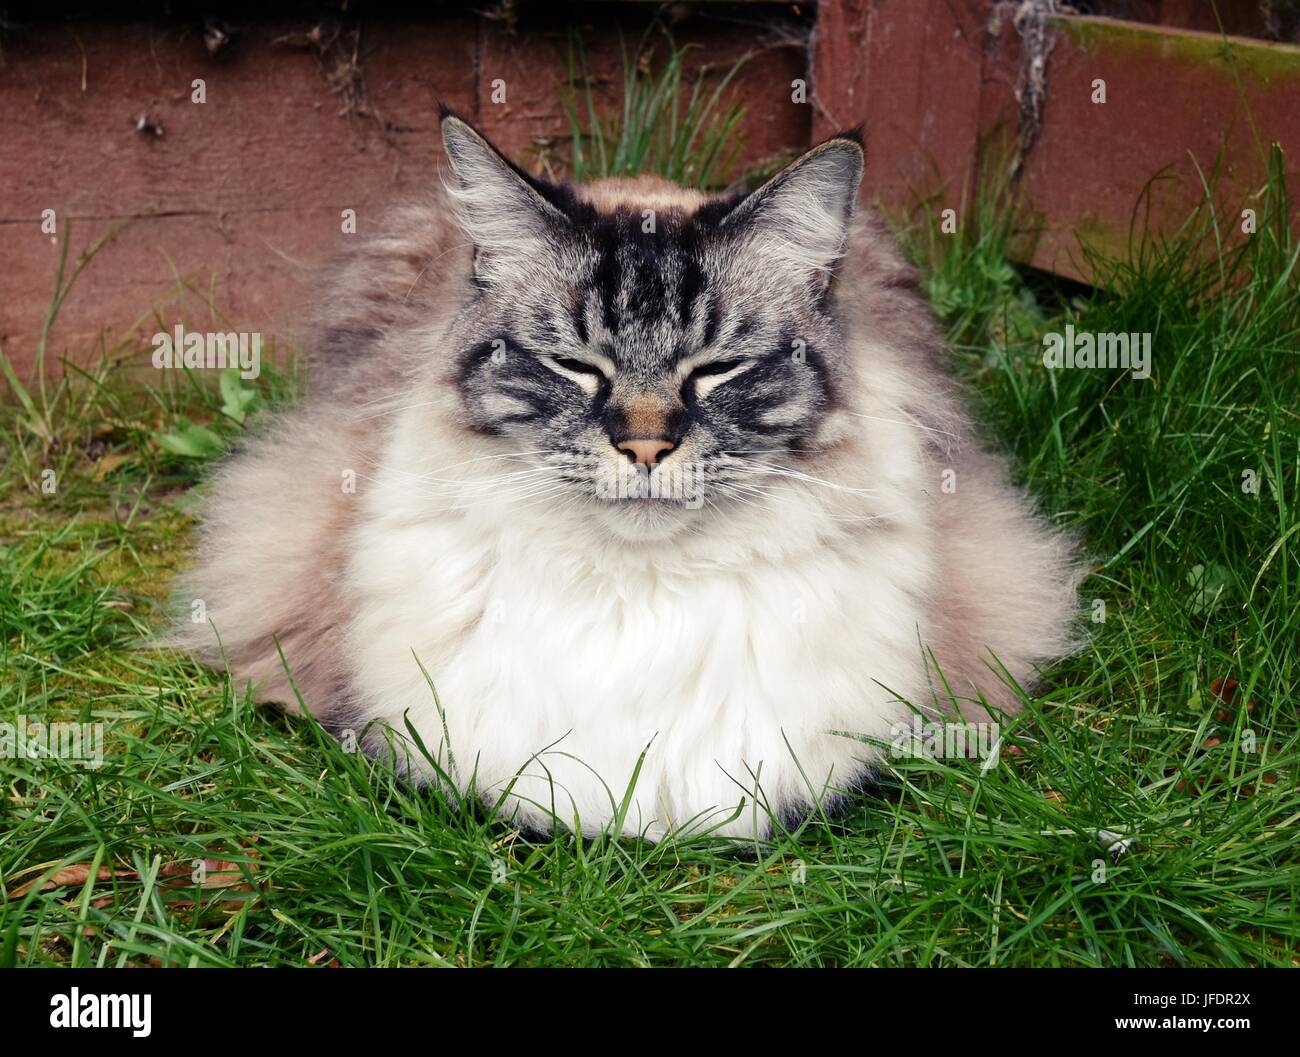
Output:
[0, 7, 811, 374]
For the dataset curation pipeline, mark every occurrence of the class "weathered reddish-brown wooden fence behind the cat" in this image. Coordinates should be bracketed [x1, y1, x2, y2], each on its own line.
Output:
[0, 0, 1300, 373]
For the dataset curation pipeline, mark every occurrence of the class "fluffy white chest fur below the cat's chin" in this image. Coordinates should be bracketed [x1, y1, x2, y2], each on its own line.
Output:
[346, 408, 932, 837]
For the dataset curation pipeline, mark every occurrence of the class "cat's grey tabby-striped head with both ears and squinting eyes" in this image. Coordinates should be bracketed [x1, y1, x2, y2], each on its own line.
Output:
[442, 113, 863, 541]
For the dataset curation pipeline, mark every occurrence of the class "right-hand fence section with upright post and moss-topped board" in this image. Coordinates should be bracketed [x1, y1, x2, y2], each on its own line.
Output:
[814, 0, 1300, 281]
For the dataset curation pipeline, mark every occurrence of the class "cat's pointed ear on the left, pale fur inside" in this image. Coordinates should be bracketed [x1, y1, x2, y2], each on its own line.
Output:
[442, 111, 567, 281]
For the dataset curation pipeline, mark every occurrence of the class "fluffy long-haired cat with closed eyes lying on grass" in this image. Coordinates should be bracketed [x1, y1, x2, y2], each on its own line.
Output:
[178, 113, 1076, 839]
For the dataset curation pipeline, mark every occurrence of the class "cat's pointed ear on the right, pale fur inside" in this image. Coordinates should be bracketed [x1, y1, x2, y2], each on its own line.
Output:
[722, 133, 865, 293]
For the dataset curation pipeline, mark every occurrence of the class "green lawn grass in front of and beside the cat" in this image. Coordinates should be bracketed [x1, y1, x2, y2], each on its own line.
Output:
[0, 119, 1300, 966]
